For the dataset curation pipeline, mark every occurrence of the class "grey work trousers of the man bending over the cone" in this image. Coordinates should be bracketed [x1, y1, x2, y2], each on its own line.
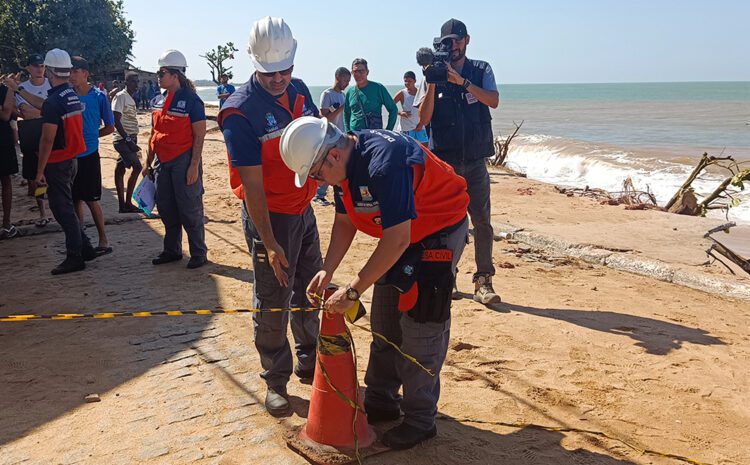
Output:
[365, 221, 468, 430]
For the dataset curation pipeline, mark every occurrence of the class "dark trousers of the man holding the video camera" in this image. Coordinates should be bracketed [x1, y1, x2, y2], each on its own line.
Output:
[452, 158, 495, 280]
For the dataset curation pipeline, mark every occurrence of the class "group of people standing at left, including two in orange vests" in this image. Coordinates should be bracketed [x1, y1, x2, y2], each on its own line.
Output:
[0, 49, 206, 275]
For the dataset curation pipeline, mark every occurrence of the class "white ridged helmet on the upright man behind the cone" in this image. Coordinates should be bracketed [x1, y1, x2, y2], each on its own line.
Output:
[247, 16, 297, 73]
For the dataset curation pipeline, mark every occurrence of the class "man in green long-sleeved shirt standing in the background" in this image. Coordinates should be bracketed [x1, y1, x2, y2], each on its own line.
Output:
[344, 58, 398, 131]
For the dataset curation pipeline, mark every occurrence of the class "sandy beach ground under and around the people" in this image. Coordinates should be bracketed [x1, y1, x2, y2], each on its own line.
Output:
[0, 109, 750, 465]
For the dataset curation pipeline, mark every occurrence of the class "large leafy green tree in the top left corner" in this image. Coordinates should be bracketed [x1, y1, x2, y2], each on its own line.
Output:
[0, 0, 135, 74]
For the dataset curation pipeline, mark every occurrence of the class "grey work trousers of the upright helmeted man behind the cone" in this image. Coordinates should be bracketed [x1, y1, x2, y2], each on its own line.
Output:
[242, 203, 323, 386]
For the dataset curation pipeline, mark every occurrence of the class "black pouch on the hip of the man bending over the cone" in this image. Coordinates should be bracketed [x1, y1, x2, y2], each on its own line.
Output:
[385, 219, 464, 323]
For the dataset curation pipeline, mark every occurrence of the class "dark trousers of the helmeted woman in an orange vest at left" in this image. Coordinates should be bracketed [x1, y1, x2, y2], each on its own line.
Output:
[154, 151, 208, 257]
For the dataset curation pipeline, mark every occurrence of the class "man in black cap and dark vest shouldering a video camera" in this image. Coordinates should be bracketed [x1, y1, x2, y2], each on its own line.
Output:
[414, 19, 500, 305]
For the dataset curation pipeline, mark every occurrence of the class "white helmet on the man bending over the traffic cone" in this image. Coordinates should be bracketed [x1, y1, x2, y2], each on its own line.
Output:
[279, 116, 344, 187]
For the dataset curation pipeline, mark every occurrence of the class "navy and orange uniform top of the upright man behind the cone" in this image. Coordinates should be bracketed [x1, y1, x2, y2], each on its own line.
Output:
[217, 76, 317, 215]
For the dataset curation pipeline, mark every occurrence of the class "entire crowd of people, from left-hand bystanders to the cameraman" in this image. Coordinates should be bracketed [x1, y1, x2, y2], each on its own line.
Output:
[0, 17, 500, 449]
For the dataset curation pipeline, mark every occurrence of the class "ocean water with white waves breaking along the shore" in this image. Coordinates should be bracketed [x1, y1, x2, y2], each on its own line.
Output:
[199, 82, 750, 223]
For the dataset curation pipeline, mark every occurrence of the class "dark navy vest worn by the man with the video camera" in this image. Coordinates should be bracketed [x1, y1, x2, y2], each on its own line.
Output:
[430, 58, 495, 163]
